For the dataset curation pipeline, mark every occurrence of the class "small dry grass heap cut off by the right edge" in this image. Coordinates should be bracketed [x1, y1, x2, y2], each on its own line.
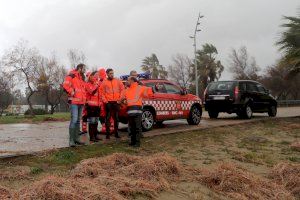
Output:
[270, 163, 300, 198]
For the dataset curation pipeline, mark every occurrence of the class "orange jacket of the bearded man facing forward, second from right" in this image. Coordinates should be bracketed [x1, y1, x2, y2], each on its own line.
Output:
[100, 78, 124, 103]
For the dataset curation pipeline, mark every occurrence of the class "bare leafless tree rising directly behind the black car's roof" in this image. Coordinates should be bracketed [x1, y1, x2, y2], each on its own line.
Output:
[229, 46, 260, 80]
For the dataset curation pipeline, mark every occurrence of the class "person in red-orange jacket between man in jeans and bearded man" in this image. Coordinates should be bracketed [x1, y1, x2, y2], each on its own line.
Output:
[86, 71, 102, 142]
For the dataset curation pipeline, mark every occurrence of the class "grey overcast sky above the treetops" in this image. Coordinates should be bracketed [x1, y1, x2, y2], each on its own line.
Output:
[0, 0, 300, 79]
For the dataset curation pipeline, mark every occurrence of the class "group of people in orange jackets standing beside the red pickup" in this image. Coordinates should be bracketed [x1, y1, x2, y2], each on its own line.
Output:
[63, 64, 153, 147]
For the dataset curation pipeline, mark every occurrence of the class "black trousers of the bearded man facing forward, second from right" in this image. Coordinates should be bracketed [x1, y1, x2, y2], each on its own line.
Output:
[105, 102, 120, 135]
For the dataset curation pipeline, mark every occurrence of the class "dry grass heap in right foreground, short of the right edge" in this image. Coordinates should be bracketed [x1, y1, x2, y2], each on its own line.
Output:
[199, 163, 294, 200]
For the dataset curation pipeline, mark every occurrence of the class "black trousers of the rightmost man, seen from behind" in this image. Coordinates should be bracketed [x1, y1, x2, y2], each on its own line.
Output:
[128, 114, 142, 145]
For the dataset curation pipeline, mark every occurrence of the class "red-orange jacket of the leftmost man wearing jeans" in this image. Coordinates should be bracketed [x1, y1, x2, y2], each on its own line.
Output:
[63, 70, 86, 104]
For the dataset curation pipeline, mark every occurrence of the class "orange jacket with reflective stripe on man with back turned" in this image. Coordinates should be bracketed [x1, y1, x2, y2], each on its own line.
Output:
[122, 83, 153, 107]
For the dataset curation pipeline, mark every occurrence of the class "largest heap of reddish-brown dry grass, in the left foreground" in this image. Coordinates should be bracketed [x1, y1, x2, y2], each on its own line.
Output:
[9, 153, 184, 200]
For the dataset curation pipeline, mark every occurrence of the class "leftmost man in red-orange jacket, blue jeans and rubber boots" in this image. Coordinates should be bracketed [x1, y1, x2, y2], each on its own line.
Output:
[63, 64, 86, 147]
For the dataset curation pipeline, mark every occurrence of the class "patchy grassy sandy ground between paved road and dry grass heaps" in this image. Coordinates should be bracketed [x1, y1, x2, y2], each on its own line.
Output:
[0, 117, 300, 200]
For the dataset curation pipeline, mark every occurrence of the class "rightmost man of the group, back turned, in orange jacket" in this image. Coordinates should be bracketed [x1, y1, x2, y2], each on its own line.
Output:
[121, 76, 153, 147]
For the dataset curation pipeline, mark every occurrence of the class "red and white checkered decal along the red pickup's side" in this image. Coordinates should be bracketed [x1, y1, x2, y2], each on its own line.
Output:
[143, 100, 201, 111]
